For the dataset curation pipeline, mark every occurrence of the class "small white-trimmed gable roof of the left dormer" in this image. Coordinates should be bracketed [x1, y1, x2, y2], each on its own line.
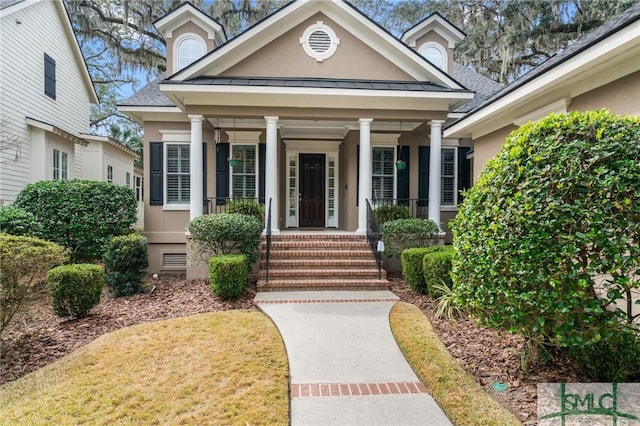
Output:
[153, 2, 227, 46]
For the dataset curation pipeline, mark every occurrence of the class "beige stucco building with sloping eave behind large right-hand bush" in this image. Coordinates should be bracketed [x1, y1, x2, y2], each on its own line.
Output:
[443, 3, 640, 181]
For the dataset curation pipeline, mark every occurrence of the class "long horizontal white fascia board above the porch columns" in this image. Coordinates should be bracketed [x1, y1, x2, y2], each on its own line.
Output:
[160, 84, 474, 101]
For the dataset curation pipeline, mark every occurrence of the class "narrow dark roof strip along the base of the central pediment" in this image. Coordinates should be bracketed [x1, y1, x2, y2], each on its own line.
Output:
[172, 77, 466, 92]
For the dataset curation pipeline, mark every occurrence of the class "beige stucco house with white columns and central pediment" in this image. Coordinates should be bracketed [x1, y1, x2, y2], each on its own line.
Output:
[119, 0, 501, 272]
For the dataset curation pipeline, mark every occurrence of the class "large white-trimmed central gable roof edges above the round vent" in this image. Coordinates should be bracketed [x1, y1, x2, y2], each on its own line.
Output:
[168, 0, 464, 89]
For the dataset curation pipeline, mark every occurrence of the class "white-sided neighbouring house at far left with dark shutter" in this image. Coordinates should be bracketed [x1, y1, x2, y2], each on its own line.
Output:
[0, 0, 142, 210]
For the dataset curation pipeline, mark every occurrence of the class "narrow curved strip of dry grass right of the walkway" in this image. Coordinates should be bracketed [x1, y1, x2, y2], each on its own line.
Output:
[390, 302, 521, 426]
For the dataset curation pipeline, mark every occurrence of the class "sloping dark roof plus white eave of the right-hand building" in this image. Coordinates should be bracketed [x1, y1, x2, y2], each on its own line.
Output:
[444, 3, 640, 137]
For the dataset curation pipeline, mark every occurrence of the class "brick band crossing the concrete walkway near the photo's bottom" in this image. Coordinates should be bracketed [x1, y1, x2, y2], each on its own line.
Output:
[291, 382, 429, 398]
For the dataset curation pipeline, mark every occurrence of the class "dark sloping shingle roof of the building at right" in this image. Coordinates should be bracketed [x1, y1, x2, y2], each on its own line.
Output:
[456, 2, 640, 120]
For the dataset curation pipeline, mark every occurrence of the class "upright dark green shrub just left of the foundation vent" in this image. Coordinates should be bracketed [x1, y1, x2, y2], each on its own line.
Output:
[102, 234, 149, 297]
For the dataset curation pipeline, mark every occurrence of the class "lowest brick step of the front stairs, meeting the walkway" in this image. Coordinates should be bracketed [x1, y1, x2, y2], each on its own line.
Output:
[258, 278, 389, 291]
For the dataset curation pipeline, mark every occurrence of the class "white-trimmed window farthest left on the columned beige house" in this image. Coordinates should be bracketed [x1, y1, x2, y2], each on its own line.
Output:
[165, 143, 191, 204]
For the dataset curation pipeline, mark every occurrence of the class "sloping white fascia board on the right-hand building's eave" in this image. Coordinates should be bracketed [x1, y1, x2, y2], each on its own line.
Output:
[443, 22, 640, 138]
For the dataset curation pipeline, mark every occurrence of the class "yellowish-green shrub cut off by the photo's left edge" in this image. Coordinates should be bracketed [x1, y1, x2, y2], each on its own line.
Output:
[0, 233, 66, 333]
